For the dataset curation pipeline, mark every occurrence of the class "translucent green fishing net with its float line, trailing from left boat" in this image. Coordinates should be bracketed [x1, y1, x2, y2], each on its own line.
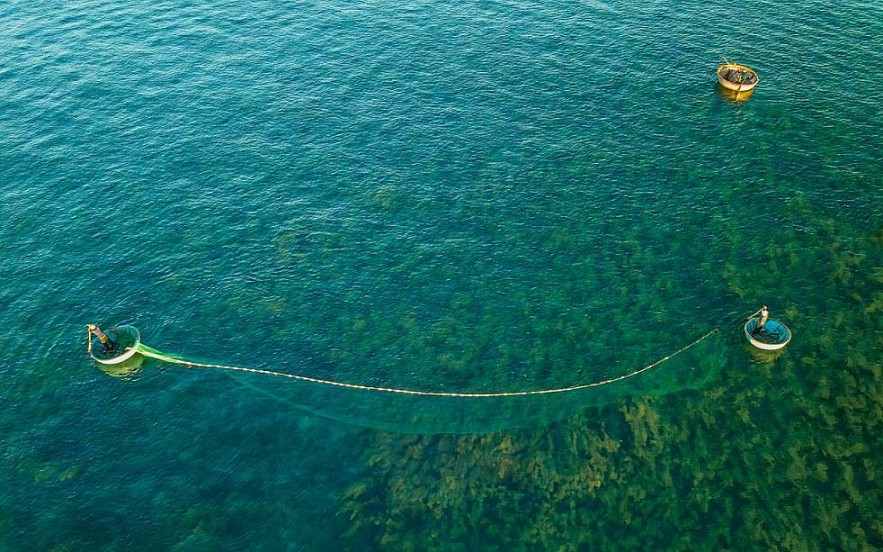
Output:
[129, 330, 724, 434]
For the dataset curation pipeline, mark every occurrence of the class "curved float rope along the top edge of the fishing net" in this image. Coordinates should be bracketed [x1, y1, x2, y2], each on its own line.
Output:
[136, 328, 719, 399]
